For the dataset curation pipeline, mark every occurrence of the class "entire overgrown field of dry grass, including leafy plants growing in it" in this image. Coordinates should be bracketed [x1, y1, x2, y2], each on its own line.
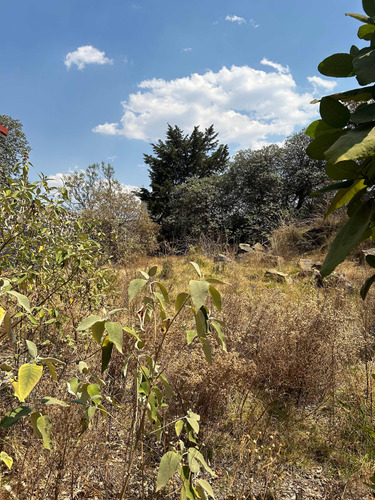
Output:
[0, 244, 375, 500]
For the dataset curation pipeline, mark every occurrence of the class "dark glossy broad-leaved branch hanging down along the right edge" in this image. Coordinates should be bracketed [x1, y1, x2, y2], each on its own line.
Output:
[306, 0, 375, 292]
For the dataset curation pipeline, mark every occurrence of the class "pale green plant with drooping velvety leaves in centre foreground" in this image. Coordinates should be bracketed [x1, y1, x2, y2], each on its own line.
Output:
[78, 262, 226, 499]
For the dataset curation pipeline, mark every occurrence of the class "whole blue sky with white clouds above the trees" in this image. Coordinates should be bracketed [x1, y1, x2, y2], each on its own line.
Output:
[0, 0, 363, 187]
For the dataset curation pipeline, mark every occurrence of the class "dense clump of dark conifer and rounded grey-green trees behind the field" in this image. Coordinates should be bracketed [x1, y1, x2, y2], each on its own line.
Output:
[138, 125, 326, 244]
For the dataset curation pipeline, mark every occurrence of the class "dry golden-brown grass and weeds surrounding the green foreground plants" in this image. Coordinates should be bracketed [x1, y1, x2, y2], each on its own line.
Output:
[1, 245, 375, 500]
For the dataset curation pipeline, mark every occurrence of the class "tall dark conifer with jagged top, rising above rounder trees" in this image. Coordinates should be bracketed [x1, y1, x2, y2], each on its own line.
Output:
[139, 125, 229, 238]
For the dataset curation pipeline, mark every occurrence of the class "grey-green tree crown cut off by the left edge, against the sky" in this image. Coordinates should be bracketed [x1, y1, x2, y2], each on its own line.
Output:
[0, 115, 31, 182]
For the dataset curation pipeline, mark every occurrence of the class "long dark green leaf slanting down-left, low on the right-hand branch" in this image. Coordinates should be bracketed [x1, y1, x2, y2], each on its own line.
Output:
[320, 202, 373, 276]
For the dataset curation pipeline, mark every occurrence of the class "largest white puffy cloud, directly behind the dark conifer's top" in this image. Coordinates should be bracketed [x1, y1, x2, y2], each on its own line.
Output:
[93, 59, 317, 148]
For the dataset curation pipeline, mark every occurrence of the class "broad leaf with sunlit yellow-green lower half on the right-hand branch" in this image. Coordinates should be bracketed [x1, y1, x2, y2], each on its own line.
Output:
[325, 127, 375, 163]
